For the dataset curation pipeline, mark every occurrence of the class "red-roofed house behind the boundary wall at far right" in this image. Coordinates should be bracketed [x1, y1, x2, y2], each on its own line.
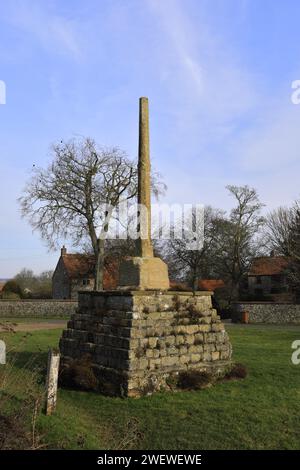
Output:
[248, 256, 290, 295]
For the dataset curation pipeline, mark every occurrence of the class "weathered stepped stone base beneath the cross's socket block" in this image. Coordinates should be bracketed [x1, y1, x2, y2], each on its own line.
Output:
[60, 290, 231, 397]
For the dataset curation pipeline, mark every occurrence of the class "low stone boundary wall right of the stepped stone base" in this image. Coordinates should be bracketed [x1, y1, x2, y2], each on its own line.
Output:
[232, 302, 300, 325]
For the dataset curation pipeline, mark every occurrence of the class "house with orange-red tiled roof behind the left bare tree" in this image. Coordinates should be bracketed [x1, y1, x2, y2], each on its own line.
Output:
[52, 247, 117, 300]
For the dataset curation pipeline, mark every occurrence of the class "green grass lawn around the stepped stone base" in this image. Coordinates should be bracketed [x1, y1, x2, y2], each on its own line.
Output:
[0, 325, 300, 450]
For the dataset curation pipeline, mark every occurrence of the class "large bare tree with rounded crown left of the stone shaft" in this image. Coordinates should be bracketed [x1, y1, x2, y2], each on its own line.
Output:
[19, 138, 137, 290]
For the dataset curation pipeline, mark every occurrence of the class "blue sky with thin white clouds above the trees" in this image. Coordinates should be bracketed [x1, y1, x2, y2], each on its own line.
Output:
[0, 0, 300, 278]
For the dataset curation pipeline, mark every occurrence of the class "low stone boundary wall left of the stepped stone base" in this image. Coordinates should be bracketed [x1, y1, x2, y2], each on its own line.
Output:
[0, 299, 78, 319]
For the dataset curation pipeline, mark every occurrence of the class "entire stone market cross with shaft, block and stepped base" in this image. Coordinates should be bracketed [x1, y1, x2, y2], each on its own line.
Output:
[60, 98, 232, 397]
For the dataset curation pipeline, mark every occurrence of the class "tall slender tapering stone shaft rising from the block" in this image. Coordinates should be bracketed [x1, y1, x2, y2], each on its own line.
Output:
[136, 97, 153, 258]
